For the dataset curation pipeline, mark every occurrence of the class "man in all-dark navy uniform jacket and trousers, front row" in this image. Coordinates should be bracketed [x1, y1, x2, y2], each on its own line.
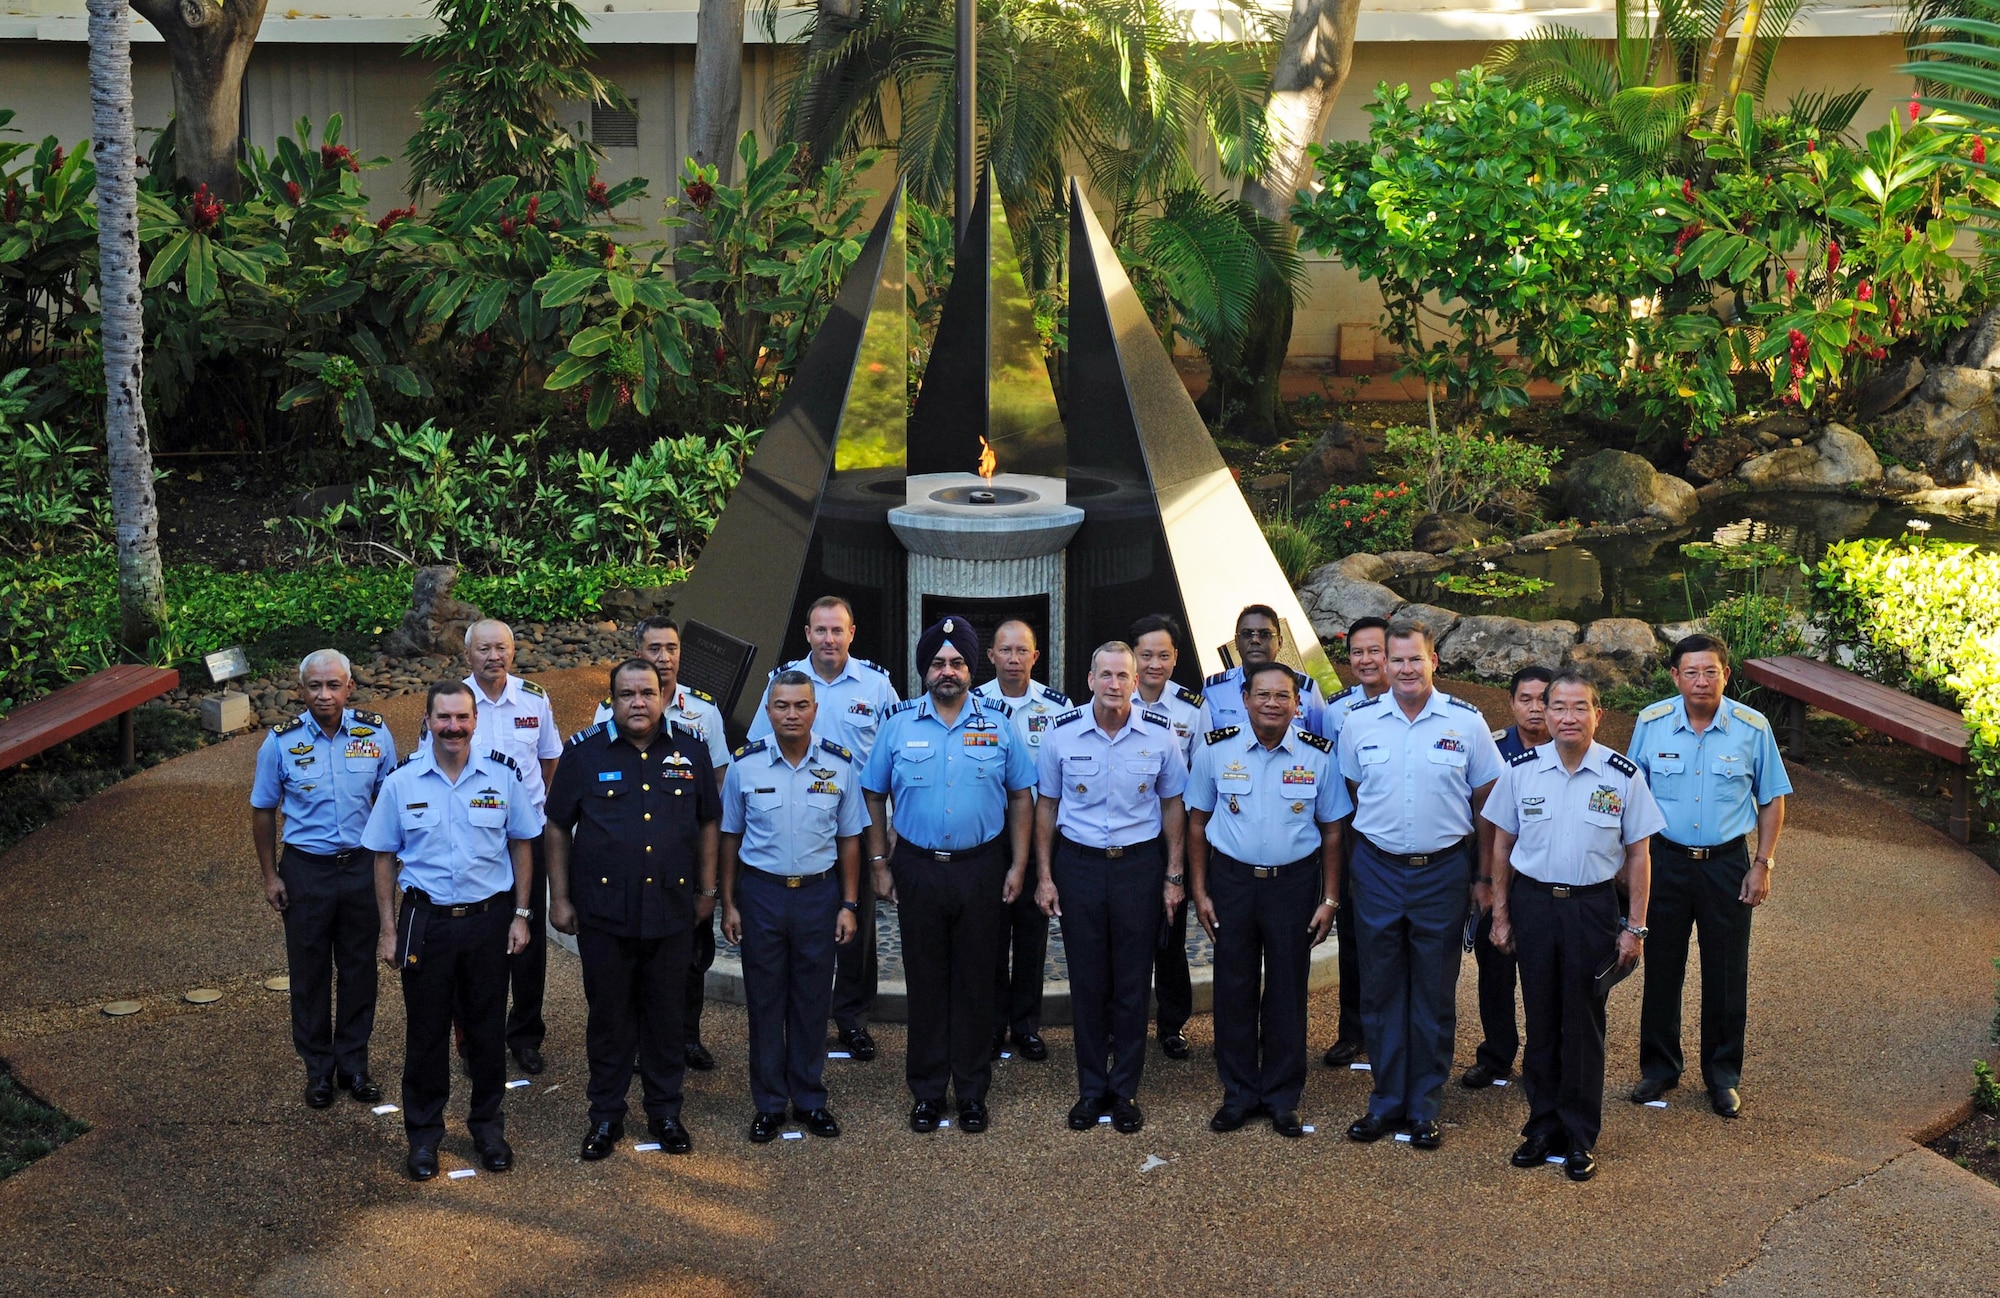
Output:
[546, 658, 722, 1160]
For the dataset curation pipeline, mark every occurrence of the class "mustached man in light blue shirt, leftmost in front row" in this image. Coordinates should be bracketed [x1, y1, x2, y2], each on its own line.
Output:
[362, 680, 542, 1180]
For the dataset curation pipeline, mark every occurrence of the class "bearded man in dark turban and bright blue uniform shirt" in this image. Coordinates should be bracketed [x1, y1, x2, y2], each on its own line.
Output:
[862, 616, 1034, 1132]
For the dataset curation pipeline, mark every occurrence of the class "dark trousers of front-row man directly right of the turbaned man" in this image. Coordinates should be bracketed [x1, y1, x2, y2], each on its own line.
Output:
[1050, 840, 1166, 1100]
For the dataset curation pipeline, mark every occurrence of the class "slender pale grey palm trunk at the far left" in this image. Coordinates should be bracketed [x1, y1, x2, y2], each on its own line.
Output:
[90, 0, 166, 652]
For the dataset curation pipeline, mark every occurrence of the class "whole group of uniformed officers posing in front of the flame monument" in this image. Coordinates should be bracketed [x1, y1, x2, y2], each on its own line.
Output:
[250, 596, 1790, 1180]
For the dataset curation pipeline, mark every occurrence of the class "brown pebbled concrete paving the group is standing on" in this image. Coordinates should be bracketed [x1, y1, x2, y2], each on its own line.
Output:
[0, 672, 2000, 1294]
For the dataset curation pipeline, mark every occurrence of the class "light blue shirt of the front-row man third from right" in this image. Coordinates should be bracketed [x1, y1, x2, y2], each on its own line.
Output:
[1188, 728, 1354, 866]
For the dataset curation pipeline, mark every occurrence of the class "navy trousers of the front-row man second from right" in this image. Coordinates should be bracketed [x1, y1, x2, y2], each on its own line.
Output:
[1354, 838, 1472, 1126]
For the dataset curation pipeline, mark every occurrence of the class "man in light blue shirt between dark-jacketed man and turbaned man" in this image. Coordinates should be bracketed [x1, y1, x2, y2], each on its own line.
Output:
[722, 672, 868, 1144]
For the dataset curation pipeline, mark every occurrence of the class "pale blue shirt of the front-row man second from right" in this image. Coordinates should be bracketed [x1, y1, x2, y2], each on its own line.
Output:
[1338, 690, 1502, 856]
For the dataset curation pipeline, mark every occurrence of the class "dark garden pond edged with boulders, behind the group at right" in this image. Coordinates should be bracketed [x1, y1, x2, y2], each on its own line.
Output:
[1392, 494, 2000, 622]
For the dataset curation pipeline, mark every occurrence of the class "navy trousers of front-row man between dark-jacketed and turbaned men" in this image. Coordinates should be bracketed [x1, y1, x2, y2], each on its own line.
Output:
[736, 866, 852, 1114]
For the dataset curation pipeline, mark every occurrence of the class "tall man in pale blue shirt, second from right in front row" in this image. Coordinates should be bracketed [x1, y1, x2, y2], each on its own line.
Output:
[1340, 622, 1500, 1150]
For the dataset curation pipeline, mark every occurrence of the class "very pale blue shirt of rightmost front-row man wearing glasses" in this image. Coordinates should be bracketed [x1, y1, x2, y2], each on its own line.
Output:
[1480, 740, 1666, 884]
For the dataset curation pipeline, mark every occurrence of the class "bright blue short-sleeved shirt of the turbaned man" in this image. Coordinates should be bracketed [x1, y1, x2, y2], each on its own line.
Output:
[862, 694, 1034, 852]
